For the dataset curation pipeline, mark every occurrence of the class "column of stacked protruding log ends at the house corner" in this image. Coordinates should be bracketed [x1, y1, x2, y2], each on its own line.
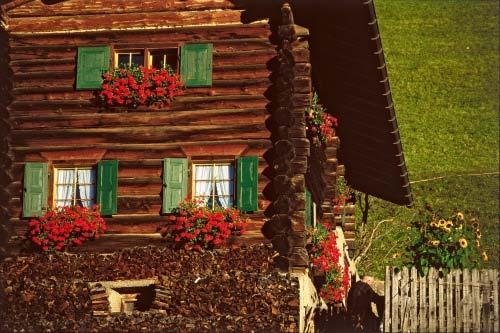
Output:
[263, 4, 311, 268]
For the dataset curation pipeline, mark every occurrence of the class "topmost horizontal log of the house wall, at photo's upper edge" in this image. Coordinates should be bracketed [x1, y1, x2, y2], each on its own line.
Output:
[9, 0, 237, 17]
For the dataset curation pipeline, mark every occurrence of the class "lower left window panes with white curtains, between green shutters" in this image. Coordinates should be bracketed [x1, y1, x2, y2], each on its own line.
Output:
[54, 167, 96, 208]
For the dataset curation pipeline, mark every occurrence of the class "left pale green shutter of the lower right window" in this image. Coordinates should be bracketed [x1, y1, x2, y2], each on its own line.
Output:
[163, 158, 188, 213]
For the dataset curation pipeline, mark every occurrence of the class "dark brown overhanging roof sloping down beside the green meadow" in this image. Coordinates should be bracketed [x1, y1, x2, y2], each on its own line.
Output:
[304, 0, 413, 205]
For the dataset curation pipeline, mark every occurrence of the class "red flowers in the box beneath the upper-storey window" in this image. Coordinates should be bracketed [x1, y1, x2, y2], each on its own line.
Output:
[98, 66, 184, 108]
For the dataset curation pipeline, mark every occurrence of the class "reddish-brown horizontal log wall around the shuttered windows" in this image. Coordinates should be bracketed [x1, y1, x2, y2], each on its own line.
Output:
[0, 0, 311, 249]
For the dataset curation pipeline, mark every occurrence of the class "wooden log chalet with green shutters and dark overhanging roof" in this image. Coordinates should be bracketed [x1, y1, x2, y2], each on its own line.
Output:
[0, 0, 411, 266]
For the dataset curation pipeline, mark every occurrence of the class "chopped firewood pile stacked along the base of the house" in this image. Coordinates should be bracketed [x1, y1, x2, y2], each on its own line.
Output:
[0, 245, 299, 332]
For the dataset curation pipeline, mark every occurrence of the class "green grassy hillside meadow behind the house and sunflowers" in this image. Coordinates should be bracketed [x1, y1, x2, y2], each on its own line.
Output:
[357, 0, 500, 277]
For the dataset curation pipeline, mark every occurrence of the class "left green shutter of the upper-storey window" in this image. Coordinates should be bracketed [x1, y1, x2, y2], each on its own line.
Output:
[76, 46, 110, 89]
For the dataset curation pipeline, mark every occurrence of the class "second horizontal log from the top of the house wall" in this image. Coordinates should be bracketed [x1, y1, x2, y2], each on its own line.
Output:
[9, 10, 247, 32]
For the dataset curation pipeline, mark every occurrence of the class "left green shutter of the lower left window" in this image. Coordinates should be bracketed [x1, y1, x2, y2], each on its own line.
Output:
[23, 163, 49, 217]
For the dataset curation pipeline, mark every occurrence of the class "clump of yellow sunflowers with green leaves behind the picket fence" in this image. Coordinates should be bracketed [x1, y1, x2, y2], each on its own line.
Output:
[406, 213, 488, 275]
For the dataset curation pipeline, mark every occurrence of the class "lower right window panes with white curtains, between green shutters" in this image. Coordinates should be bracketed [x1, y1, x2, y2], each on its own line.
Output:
[193, 163, 234, 209]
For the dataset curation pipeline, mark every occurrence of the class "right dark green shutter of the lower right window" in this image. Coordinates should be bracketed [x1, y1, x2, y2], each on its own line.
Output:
[236, 156, 259, 212]
